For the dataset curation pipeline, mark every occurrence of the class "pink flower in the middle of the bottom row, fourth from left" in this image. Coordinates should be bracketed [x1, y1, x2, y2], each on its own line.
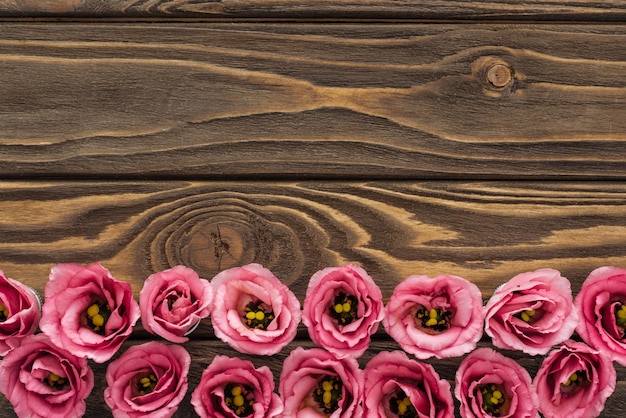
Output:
[278, 347, 363, 418]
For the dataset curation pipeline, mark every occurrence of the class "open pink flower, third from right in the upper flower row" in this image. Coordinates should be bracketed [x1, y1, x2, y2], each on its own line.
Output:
[383, 275, 483, 359]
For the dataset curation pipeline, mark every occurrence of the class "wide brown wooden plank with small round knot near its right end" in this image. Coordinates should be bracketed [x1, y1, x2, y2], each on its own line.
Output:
[0, 23, 626, 179]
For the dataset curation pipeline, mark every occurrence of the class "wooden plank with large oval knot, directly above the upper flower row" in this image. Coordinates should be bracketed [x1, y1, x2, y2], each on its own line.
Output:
[0, 181, 626, 300]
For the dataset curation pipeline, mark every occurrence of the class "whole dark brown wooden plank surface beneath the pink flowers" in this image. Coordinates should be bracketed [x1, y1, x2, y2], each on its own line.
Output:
[0, 0, 626, 417]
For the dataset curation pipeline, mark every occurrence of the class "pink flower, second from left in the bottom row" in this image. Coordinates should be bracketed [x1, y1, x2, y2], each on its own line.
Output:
[104, 341, 191, 418]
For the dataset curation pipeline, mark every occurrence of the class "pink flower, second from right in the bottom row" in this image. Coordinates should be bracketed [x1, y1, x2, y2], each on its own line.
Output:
[454, 348, 539, 418]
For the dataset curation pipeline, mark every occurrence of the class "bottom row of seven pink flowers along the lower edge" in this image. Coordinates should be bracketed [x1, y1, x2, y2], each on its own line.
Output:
[0, 334, 616, 418]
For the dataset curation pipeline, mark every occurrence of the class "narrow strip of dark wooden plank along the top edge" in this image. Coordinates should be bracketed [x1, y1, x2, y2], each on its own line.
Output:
[0, 0, 626, 21]
